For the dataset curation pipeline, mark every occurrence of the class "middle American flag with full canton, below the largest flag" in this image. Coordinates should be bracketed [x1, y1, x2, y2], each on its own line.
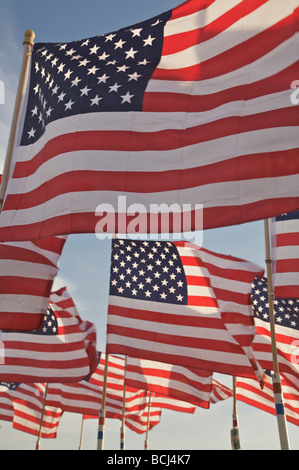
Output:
[107, 239, 260, 376]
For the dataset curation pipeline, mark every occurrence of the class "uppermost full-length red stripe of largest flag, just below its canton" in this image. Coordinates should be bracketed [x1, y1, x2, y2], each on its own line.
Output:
[11, 106, 298, 179]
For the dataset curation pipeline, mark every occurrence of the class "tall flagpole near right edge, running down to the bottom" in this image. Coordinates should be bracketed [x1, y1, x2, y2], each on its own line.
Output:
[264, 219, 290, 450]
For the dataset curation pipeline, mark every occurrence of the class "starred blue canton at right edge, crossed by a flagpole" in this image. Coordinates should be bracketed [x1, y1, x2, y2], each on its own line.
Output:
[251, 278, 299, 330]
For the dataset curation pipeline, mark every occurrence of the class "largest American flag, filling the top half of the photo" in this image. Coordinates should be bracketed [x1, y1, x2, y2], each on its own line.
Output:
[0, 0, 299, 242]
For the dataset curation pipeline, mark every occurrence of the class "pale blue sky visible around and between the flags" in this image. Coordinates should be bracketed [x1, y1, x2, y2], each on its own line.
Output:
[0, 0, 299, 450]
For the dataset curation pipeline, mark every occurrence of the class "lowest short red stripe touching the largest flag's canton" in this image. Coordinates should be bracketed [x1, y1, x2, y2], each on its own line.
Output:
[143, 63, 298, 112]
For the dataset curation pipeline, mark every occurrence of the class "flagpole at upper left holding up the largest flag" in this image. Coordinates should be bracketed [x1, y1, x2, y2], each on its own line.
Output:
[0, 29, 35, 212]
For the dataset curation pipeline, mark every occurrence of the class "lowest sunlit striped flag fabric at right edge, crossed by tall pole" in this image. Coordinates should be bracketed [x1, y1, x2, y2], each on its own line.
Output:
[236, 376, 299, 426]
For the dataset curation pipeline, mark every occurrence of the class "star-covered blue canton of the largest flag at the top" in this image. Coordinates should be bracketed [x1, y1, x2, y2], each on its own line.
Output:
[21, 11, 171, 145]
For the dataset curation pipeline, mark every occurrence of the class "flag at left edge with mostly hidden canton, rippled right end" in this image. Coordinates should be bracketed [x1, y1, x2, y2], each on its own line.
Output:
[0, 291, 97, 383]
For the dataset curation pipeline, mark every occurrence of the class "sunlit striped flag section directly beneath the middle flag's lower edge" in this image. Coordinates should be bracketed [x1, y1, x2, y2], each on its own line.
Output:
[125, 357, 212, 408]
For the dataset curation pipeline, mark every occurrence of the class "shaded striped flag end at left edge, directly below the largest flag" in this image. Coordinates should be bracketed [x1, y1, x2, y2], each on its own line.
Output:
[0, 237, 66, 331]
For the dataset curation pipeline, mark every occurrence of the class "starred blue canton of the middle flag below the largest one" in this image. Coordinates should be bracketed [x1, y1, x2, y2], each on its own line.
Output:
[110, 239, 188, 305]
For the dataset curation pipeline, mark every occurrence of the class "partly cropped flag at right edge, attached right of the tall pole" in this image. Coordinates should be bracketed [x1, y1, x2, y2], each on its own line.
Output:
[270, 210, 299, 299]
